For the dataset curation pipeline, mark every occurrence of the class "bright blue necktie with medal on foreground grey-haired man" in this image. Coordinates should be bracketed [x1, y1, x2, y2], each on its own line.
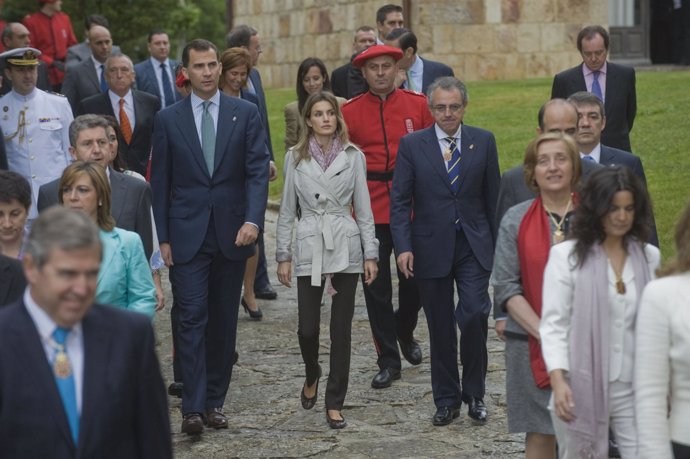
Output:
[53, 327, 79, 445]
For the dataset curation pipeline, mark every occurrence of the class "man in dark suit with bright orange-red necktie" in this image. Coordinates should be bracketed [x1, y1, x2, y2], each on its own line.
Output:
[77, 55, 161, 176]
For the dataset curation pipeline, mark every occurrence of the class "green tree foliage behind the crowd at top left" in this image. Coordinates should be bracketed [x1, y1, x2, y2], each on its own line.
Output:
[2, 0, 226, 62]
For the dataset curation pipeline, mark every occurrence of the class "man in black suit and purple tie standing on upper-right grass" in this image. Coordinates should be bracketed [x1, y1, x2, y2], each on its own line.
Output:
[551, 26, 637, 151]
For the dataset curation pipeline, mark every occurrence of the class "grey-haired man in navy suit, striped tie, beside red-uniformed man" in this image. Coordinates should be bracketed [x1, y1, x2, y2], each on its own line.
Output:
[391, 77, 500, 426]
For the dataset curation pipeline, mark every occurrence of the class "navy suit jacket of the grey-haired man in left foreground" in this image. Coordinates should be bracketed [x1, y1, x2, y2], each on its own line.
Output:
[0, 301, 172, 459]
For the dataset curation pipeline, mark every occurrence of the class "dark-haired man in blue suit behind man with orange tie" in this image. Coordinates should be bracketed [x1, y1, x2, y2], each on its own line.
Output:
[134, 30, 182, 107]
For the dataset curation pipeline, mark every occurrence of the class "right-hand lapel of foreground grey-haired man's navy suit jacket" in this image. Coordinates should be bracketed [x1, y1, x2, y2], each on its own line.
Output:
[79, 305, 112, 452]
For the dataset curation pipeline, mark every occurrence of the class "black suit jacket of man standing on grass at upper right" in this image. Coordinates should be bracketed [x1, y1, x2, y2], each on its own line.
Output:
[551, 62, 637, 151]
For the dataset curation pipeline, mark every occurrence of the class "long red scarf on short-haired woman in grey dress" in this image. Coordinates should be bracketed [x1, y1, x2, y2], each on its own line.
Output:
[517, 196, 551, 389]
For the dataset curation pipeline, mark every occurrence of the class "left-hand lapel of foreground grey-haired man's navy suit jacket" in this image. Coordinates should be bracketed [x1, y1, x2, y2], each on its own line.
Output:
[12, 302, 74, 449]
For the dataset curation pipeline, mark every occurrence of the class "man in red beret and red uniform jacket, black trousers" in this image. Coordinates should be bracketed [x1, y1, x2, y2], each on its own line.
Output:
[343, 45, 434, 389]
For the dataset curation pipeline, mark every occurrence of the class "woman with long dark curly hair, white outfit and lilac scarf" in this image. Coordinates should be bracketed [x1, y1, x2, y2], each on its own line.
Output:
[539, 166, 660, 459]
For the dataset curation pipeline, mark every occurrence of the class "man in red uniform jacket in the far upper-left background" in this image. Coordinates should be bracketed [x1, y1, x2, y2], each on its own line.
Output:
[22, 0, 77, 91]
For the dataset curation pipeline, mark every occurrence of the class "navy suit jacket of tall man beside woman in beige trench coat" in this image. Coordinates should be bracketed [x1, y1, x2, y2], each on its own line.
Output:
[151, 93, 269, 263]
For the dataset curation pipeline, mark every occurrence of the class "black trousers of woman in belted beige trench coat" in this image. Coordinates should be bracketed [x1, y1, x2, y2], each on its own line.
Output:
[297, 273, 358, 410]
